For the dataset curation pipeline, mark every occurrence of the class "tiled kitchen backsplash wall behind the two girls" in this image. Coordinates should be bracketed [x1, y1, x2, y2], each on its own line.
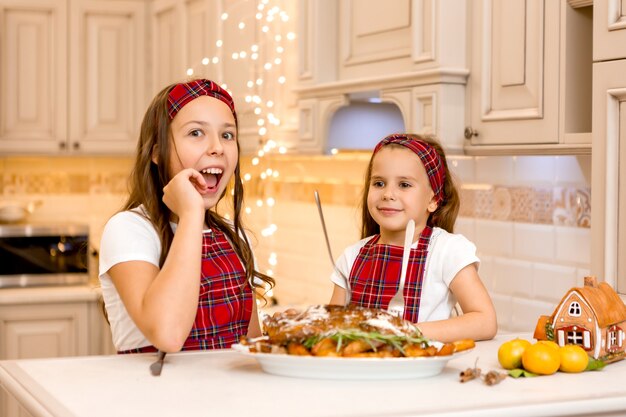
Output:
[0, 152, 591, 331]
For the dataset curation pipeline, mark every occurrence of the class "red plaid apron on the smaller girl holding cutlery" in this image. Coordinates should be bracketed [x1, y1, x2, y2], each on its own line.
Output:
[350, 226, 433, 323]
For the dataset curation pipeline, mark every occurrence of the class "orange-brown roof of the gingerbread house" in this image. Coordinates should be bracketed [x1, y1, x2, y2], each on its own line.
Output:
[553, 277, 626, 328]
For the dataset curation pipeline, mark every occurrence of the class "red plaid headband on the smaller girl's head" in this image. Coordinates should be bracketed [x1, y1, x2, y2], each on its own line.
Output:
[374, 134, 446, 203]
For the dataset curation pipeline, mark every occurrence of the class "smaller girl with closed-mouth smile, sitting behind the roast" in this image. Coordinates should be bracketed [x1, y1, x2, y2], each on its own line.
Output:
[330, 134, 497, 342]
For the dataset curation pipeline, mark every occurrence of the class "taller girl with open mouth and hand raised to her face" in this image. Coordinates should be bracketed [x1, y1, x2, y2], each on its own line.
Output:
[99, 79, 274, 353]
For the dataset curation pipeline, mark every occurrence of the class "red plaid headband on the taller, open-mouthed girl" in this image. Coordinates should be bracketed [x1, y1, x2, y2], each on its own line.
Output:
[167, 79, 237, 122]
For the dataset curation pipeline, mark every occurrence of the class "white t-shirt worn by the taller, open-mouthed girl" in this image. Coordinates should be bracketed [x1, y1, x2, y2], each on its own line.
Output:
[99, 209, 161, 351]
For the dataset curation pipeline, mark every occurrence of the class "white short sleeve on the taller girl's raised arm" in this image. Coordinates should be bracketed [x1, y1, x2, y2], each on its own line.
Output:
[99, 211, 161, 275]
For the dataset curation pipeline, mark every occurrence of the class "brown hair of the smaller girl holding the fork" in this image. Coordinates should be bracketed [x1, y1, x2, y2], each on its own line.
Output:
[361, 134, 461, 239]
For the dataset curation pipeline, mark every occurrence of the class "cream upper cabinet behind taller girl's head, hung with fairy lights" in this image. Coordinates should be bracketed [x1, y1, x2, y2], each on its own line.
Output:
[150, 0, 298, 153]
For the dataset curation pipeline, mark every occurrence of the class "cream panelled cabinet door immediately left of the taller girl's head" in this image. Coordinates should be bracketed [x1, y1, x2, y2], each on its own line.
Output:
[69, 0, 148, 153]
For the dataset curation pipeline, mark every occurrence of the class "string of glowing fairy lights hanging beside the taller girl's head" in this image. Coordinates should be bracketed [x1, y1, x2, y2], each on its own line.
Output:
[187, 0, 296, 298]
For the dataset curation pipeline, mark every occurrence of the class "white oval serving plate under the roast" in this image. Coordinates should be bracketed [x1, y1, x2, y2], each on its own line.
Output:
[232, 344, 472, 379]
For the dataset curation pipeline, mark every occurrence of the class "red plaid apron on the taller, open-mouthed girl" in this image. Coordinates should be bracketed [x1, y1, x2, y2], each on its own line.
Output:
[119, 230, 254, 353]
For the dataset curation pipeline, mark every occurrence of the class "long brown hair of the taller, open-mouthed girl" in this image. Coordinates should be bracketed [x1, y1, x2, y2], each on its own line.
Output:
[123, 80, 274, 289]
